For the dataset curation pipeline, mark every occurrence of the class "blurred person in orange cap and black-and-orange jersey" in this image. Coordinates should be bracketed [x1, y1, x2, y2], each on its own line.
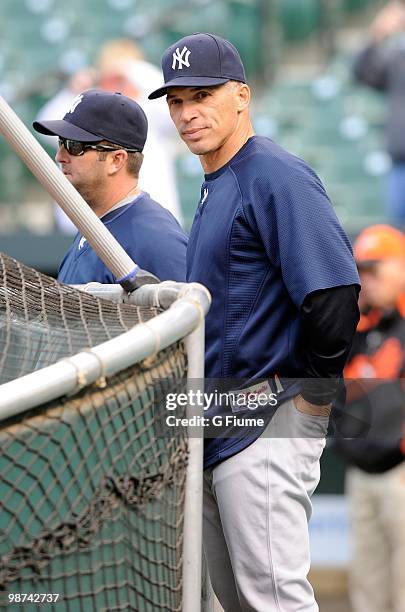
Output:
[335, 225, 405, 612]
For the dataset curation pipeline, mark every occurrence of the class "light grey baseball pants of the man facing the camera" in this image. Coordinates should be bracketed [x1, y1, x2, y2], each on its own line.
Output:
[203, 399, 328, 612]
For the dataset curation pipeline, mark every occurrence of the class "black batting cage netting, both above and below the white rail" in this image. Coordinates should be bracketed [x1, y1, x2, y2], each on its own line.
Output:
[0, 252, 187, 612]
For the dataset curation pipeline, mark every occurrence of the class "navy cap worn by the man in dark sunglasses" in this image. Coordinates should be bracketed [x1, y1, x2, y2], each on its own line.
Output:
[32, 89, 148, 151]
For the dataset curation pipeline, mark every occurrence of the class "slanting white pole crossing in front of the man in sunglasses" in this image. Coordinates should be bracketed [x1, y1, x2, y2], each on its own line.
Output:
[0, 96, 156, 290]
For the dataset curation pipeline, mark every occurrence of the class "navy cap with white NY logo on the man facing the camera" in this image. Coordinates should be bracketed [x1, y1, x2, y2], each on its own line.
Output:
[148, 32, 246, 100]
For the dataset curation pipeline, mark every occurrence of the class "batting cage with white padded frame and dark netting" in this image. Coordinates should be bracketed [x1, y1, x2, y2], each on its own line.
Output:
[0, 252, 209, 611]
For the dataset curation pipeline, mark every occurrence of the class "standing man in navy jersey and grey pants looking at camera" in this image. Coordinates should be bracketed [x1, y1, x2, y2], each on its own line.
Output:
[150, 33, 359, 612]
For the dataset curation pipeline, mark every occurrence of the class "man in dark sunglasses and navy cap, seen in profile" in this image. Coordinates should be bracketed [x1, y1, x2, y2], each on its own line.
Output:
[33, 89, 187, 284]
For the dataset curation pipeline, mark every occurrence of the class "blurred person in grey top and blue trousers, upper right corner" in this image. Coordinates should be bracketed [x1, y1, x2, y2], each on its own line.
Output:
[353, 0, 405, 229]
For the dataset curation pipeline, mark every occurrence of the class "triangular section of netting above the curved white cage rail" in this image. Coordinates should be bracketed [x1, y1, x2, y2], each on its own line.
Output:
[0, 253, 158, 384]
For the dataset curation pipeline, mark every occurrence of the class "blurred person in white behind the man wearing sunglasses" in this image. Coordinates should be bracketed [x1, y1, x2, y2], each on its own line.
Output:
[37, 38, 182, 234]
